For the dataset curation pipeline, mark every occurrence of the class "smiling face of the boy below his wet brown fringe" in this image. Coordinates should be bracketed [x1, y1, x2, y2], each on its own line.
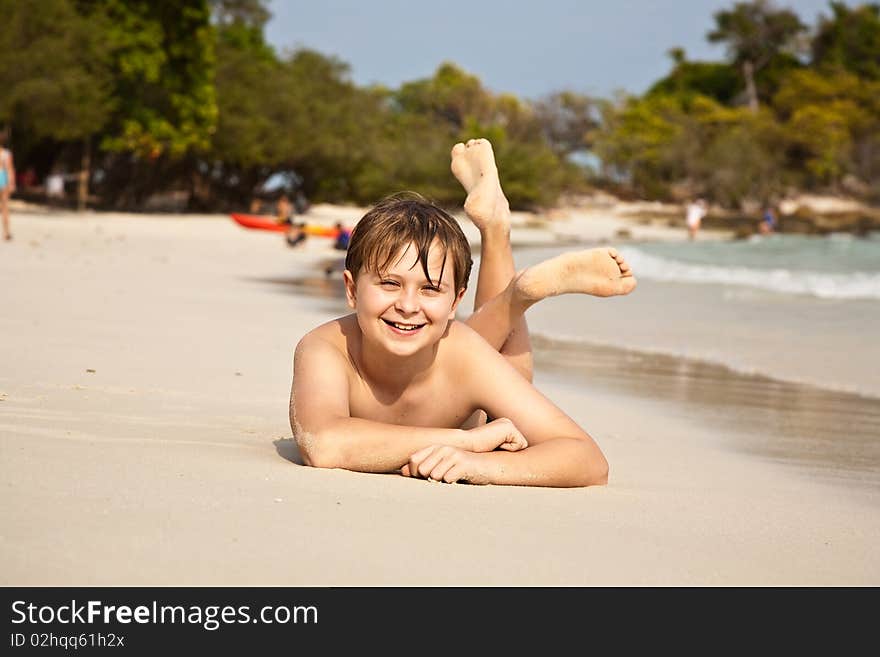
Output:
[344, 242, 464, 356]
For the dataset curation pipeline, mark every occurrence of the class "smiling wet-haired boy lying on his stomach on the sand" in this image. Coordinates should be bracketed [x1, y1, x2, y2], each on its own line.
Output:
[290, 139, 636, 486]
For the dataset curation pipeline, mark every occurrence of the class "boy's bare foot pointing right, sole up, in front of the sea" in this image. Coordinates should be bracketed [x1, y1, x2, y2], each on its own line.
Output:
[515, 247, 636, 302]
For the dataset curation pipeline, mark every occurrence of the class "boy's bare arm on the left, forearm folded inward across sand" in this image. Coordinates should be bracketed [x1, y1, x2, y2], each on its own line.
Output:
[290, 336, 503, 472]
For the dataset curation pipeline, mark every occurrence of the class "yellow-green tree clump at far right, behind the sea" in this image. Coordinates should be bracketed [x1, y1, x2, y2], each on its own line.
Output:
[595, 0, 880, 206]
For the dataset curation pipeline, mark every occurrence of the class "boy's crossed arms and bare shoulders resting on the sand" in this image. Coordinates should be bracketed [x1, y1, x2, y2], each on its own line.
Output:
[291, 316, 608, 486]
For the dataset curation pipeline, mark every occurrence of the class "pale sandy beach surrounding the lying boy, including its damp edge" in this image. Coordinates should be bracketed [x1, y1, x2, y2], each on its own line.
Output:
[0, 205, 880, 586]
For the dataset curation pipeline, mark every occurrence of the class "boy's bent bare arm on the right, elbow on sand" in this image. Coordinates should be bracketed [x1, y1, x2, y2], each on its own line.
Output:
[426, 326, 608, 486]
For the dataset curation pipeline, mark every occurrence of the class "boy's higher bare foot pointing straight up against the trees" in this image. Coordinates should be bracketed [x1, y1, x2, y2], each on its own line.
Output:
[452, 139, 510, 233]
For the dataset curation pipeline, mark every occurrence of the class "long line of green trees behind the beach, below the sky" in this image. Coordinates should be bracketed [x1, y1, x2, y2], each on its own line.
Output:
[0, 0, 880, 210]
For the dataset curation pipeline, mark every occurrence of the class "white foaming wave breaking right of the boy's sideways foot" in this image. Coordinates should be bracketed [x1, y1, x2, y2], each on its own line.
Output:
[621, 247, 880, 300]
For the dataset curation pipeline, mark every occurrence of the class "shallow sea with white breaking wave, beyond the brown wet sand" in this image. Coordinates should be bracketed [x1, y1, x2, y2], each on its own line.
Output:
[496, 234, 880, 397]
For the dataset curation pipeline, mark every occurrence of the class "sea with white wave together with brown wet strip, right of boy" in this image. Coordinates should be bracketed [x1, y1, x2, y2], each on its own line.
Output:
[492, 235, 880, 490]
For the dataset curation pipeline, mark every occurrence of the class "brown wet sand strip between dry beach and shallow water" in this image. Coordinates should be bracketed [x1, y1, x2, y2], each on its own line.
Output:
[533, 337, 880, 490]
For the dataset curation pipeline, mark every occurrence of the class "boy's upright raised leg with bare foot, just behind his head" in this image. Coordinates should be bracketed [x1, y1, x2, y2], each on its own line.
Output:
[452, 139, 532, 381]
